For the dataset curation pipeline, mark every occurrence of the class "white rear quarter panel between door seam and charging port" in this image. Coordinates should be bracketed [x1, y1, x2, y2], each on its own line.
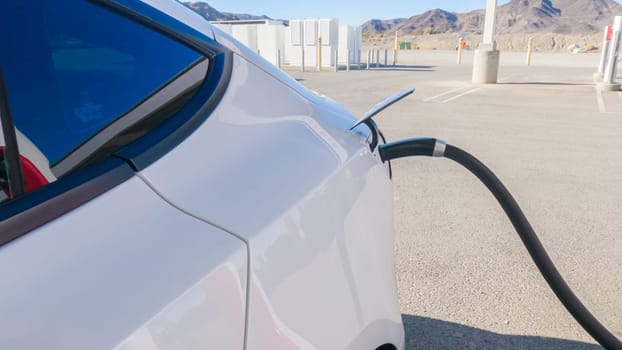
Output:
[141, 55, 403, 349]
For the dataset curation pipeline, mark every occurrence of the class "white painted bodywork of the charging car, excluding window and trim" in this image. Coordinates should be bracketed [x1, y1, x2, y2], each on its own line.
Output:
[0, 0, 404, 350]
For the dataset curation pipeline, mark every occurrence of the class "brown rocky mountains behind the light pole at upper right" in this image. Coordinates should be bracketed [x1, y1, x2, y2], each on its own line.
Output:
[363, 0, 622, 35]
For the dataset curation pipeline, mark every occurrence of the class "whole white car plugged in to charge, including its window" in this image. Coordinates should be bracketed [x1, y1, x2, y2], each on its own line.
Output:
[0, 0, 404, 350]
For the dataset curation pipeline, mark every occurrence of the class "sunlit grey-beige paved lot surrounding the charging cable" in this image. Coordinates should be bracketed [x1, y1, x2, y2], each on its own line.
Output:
[290, 51, 622, 350]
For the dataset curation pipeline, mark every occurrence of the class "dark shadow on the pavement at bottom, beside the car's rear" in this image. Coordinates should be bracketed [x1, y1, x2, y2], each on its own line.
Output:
[402, 314, 603, 350]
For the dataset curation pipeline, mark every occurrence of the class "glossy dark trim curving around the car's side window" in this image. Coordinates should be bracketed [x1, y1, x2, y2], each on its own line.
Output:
[0, 0, 233, 247]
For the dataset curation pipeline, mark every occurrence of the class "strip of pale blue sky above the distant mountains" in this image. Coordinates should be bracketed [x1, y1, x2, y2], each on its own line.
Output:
[207, 0, 509, 25]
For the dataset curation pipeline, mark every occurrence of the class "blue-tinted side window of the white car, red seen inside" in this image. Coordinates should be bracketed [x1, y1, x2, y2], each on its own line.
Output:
[0, 0, 209, 200]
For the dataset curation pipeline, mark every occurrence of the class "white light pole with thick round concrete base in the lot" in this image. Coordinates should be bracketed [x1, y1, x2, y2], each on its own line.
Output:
[473, 0, 499, 84]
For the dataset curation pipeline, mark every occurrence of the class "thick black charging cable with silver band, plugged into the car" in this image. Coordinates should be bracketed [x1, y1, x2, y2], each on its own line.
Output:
[380, 139, 622, 350]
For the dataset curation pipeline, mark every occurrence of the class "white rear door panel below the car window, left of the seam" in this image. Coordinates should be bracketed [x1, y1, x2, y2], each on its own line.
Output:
[0, 177, 247, 350]
